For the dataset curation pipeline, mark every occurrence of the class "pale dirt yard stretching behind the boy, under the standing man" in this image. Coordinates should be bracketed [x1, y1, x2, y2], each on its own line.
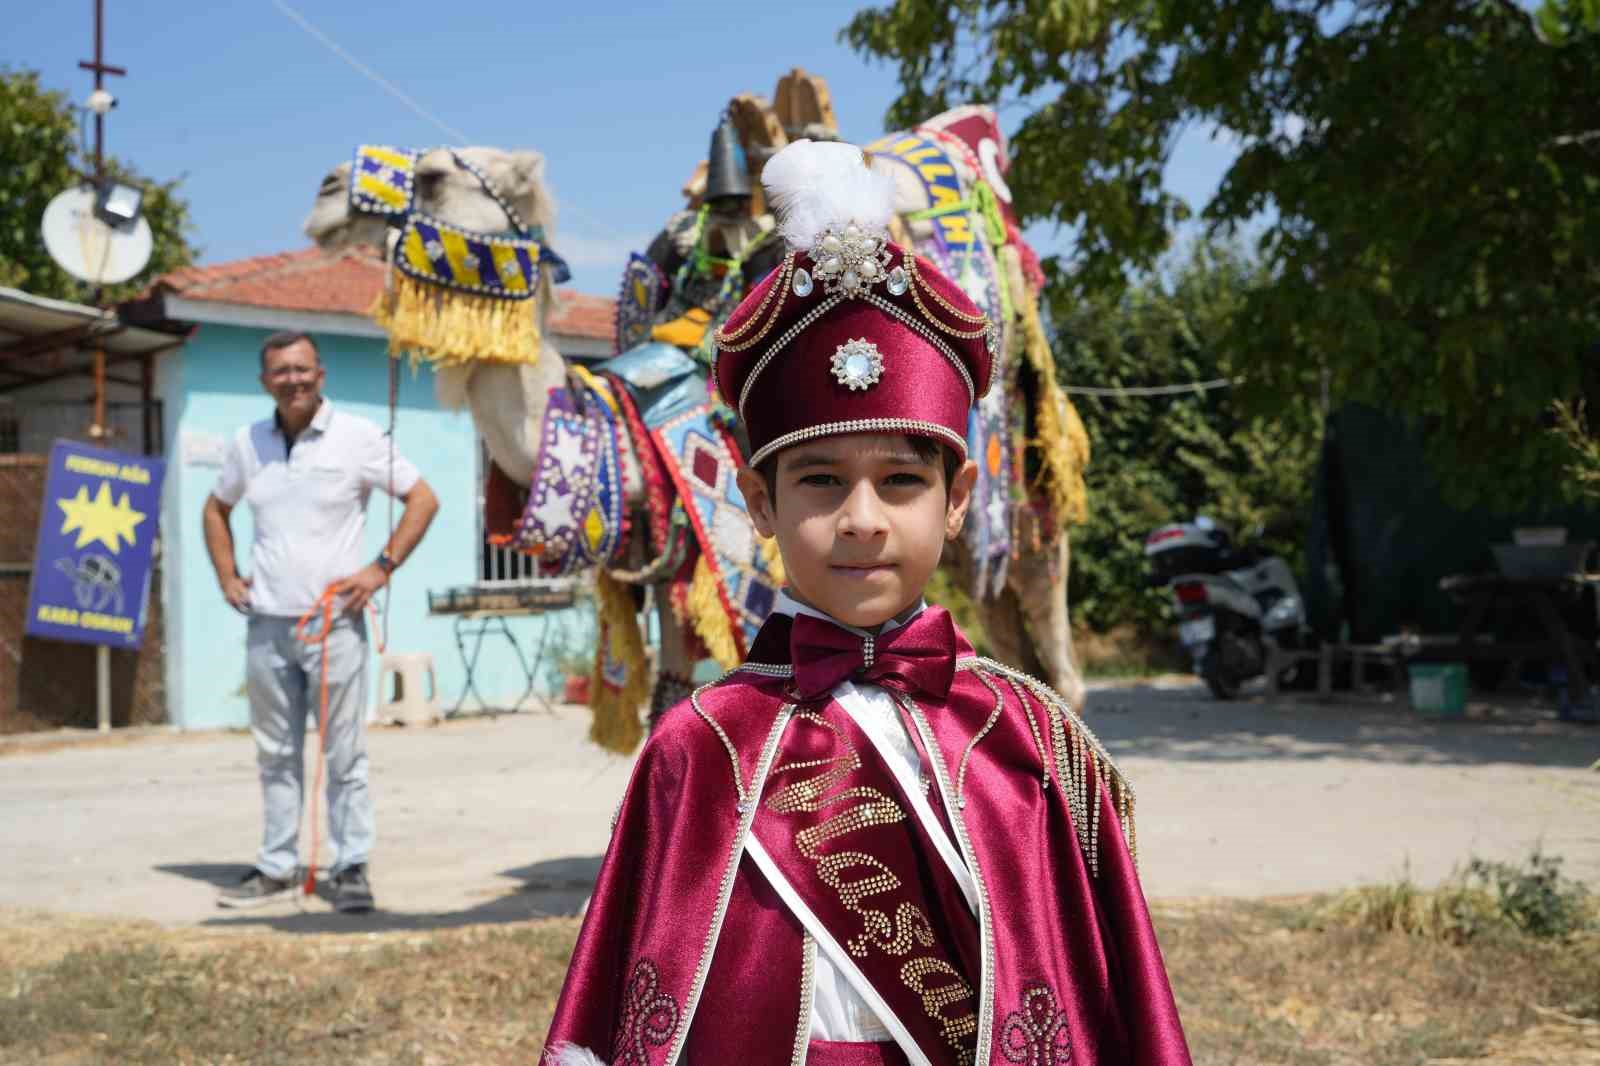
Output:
[0, 683, 1600, 932]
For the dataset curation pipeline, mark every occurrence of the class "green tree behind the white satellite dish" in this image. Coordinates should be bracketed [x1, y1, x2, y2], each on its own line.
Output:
[0, 70, 197, 304]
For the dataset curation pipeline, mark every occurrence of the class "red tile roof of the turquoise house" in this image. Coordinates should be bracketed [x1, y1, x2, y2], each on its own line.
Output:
[150, 248, 616, 341]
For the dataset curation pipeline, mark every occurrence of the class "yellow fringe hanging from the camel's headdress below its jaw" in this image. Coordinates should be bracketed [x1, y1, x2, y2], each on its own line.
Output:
[368, 271, 539, 365]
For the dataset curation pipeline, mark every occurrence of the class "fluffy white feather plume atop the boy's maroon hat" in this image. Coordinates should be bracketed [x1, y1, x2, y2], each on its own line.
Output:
[762, 139, 894, 251]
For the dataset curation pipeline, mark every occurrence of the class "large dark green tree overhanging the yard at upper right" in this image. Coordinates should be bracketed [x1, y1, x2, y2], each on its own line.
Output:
[843, 0, 1600, 504]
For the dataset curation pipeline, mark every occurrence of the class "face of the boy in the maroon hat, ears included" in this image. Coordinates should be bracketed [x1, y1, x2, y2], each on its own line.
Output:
[739, 434, 978, 629]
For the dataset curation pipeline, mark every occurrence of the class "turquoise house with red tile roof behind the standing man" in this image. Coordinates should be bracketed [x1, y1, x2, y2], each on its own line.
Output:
[139, 248, 613, 728]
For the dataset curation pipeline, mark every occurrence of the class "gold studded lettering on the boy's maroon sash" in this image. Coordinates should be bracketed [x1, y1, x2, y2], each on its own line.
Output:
[766, 711, 978, 1066]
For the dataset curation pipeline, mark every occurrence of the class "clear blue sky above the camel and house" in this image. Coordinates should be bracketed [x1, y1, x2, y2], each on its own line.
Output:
[0, 0, 1232, 295]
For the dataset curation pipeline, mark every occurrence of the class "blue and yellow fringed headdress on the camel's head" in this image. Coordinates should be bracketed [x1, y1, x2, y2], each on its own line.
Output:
[350, 144, 570, 363]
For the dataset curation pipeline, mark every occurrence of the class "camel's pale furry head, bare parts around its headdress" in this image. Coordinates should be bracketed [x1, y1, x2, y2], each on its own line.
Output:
[306, 147, 555, 251]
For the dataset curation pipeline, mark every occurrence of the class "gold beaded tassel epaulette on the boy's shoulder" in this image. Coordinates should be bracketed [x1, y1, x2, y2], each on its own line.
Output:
[978, 658, 1139, 876]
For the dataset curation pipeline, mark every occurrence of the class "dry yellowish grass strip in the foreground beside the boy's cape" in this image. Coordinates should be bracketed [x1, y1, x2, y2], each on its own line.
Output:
[0, 900, 1600, 1066]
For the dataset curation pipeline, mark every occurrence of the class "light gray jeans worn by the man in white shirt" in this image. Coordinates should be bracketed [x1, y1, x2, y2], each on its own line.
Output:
[245, 615, 376, 880]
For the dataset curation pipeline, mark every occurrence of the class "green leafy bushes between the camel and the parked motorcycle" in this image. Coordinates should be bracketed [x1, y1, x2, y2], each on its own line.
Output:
[1051, 245, 1320, 631]
